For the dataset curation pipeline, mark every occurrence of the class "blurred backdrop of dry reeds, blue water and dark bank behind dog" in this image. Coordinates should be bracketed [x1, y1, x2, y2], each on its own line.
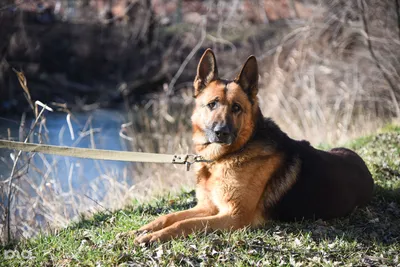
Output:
[0, 0, 400, 243]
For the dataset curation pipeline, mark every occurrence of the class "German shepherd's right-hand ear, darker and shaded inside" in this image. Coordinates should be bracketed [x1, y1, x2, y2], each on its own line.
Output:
[235, 56, 258, 99]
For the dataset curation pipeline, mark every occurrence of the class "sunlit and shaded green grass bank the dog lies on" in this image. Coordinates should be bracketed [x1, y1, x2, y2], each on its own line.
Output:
[0, 126, 400, 266]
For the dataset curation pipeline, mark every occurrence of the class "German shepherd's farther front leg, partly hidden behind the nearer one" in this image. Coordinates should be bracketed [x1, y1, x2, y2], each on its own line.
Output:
[138, 206, 213, 231]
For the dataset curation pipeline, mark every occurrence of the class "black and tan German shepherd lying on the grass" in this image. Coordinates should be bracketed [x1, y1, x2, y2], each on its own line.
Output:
[135, 49, 374, 243]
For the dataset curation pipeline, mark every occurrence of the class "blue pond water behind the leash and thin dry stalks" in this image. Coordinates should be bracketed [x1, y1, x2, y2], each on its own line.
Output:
[0, 109, 128, 201]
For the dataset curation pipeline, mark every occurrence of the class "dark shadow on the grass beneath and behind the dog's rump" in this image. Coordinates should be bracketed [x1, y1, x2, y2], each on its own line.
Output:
[276, 186, 400, 245]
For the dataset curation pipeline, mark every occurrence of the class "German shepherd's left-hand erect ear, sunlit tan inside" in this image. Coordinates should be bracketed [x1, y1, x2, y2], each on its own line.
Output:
[193, 48, 218, 97]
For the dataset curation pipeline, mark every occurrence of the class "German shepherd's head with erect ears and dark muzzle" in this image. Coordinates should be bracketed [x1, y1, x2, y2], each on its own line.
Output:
[192, 49, 259, 160]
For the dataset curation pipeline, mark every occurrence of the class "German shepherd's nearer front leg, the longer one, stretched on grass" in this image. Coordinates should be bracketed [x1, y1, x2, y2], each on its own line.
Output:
[135, 214, 250, 243]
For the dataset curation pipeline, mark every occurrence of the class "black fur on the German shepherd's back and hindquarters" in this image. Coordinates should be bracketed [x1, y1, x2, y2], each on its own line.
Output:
[258, 119, 374, 220]
